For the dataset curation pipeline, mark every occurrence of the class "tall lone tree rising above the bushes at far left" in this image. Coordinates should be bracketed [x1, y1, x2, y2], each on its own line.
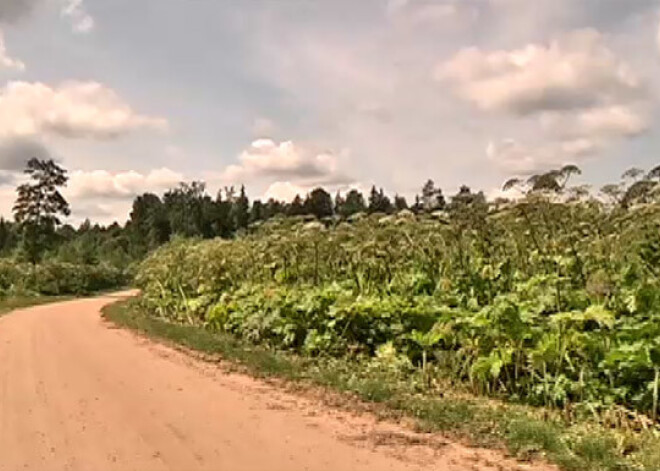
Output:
[13, 159, 71, 263]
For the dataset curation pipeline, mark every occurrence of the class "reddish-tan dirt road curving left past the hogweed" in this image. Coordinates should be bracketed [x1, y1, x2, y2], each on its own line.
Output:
[0, 297, 539, 471]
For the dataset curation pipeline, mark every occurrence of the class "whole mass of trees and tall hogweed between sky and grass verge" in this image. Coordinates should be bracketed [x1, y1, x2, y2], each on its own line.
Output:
[10, 155, 660, 432]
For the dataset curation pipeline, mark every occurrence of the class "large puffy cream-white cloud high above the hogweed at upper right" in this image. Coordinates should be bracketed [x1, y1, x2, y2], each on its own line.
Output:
[437, 29, 643, 115]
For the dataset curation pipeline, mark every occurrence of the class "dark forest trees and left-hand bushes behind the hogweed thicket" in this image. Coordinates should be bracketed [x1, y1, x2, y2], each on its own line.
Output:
[0, 159, 444, 296]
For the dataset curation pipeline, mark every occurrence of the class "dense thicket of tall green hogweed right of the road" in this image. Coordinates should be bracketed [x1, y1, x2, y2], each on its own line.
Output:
[137, 165, 660, 427]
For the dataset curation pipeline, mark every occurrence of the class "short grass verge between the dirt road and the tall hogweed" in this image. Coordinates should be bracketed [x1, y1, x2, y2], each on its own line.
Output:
[103, 299, 660, 471]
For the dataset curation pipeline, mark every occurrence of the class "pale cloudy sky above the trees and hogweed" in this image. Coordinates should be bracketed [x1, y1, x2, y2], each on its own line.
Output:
[0, 0, 660, 223]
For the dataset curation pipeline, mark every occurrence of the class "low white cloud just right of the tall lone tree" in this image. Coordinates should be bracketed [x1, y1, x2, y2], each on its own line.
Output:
[65, 168, 184, 199]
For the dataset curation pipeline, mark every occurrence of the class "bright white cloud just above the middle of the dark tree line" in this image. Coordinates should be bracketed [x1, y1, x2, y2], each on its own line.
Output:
[221, 139, 354, 185]
